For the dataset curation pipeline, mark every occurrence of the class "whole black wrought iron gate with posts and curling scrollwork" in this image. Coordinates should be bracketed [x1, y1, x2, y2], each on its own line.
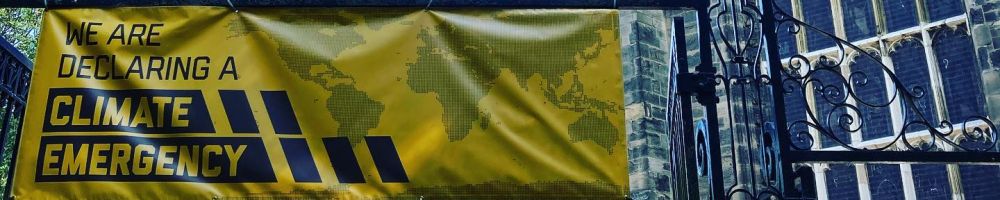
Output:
[668, 0, 1000, 199]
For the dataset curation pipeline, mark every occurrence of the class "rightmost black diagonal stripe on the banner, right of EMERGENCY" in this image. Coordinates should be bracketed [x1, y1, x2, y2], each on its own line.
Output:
[365, 136, 410, 183]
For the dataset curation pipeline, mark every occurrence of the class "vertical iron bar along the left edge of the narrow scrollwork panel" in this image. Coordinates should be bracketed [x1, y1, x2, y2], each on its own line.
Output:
[696, 1, 725, 199]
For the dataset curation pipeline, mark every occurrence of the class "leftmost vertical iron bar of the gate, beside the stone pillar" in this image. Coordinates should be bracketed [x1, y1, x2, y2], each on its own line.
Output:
[673, 17, 699, 200]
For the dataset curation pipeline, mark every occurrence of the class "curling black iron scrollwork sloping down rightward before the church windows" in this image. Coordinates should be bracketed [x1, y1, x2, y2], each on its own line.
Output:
[771, 1, 997, 152]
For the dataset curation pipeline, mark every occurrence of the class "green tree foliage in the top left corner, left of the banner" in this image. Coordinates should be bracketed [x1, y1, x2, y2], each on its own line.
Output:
[0, 8, 42, 59]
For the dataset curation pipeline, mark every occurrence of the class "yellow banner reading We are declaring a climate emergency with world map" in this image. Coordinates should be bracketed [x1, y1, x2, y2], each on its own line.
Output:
[13, 7, 628, 199]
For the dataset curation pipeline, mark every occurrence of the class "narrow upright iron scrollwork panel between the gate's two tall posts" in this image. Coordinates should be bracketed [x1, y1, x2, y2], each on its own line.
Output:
[706, 0, 784, 199]
